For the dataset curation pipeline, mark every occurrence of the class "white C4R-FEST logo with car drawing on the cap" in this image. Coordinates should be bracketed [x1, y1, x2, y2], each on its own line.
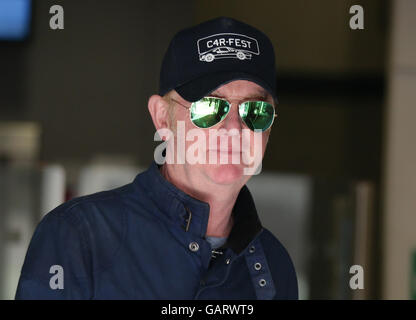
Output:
[197, 33, 260, 62]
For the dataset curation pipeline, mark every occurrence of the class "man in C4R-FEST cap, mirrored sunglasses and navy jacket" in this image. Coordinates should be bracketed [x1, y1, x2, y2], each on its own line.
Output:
[16, 18, 298, 299]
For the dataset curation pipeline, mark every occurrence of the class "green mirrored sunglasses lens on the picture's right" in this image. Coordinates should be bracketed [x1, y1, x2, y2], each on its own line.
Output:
[239, 101, 274, 131]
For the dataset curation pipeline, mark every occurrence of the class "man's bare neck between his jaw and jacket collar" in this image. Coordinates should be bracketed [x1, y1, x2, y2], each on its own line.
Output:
[160, 164, 242, 237]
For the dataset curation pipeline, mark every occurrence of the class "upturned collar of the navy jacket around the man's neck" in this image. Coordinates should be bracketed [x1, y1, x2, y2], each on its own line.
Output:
[133, 161, 262, 254]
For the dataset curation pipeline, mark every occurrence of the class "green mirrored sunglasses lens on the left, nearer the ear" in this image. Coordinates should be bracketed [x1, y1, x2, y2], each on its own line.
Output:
[191, 97, 230, 128]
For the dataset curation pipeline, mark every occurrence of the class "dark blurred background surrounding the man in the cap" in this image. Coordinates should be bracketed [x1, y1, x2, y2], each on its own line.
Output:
[0, 0, 416, 299]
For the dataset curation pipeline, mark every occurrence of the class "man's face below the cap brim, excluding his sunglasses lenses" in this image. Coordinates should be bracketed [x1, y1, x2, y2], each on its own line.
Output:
[164, 80, 274, 185]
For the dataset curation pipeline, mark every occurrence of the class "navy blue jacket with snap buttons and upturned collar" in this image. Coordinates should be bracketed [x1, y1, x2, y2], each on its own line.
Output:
[16, 163, 298, 299]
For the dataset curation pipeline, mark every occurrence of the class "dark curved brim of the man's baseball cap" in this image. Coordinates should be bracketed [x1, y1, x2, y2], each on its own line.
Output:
[175, 71, 277, 103]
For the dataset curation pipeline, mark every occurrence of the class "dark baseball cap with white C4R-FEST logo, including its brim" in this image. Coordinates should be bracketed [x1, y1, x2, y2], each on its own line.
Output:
[159, 17, 277, 102]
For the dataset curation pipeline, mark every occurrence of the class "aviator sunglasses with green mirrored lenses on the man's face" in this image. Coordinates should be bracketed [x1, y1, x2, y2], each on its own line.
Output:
[171, 97, 277, 131]
